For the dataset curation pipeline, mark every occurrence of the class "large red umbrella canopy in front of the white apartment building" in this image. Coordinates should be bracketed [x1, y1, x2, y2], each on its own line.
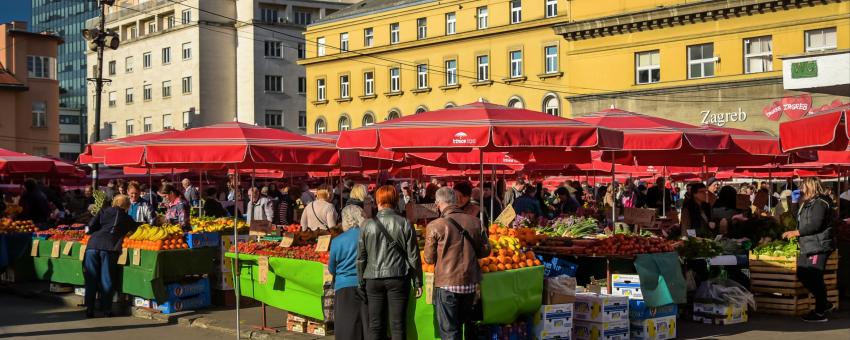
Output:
[97, 122, 340, 169]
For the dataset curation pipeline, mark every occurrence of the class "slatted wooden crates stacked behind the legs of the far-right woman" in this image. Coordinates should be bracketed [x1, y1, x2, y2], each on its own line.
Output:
[749, 252, 838, 315]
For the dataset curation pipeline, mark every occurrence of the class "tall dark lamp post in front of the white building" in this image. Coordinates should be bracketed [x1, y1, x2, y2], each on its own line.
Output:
[81, 0, 120, 189]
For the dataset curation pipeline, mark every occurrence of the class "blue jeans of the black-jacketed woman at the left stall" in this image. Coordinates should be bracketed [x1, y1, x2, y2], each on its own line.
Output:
[83, 249, 118, 313]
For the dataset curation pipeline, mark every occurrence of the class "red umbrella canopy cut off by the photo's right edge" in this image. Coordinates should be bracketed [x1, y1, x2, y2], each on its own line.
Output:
[779, 104, 850, 152]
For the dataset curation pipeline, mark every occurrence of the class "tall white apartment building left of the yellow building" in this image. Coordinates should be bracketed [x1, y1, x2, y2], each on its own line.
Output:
[86, 0, 355, 139]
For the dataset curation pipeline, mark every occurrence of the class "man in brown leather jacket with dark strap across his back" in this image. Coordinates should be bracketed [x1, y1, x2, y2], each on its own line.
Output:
[424, 187, 490, 340]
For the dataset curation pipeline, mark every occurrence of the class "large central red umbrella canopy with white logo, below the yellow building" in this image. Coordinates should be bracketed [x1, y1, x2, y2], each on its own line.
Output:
[337, 102, 622, 152]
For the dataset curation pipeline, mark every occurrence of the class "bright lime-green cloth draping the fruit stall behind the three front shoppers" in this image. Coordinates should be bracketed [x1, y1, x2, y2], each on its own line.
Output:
[226, 253, 543, 339]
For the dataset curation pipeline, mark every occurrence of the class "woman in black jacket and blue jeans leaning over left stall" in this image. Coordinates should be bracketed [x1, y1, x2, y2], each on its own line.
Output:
[83, 195, 140, 318]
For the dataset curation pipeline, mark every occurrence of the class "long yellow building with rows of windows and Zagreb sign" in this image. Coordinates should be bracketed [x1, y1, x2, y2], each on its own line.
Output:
[300, 0, 850, 133]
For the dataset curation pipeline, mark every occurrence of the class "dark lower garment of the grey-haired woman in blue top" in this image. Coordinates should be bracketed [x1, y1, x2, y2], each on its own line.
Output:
[334, 287, 369, 340]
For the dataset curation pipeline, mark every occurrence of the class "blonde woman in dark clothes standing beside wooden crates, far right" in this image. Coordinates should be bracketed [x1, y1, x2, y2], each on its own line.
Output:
[782, 177, 835, 322]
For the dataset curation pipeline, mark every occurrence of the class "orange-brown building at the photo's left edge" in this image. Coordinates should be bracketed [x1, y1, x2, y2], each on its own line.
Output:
[0, 21, 64, 156]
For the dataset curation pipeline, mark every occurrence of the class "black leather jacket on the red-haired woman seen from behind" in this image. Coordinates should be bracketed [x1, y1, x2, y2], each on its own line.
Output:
[357, 209, 422, 288]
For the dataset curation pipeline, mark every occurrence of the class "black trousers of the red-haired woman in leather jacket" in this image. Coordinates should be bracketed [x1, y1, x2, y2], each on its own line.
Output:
[366, 277, 410, 340]
